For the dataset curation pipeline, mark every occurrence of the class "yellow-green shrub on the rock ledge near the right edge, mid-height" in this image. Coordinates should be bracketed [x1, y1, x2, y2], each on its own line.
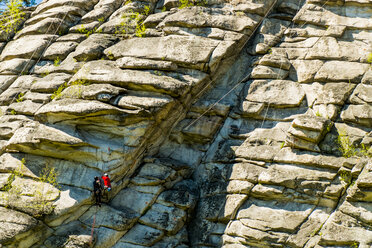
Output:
[337, 130, 372, 158]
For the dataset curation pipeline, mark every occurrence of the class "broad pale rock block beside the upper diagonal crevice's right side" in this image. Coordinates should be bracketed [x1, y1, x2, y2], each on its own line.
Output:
[246, 80, 305, 107]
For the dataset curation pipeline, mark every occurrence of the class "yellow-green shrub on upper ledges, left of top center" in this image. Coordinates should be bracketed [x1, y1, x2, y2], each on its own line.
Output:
[115, 5, 150, 38]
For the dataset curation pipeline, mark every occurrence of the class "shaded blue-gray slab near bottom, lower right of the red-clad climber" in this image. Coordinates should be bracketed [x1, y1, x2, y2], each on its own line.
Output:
[139, 203, 187, 234]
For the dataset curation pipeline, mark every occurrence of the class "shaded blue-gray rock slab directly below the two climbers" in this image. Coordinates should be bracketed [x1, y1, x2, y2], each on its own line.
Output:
[79, 205, 139, 231]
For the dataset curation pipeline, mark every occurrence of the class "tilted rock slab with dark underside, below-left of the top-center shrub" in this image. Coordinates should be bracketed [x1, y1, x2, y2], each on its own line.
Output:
[73, 34, 117, 61]
